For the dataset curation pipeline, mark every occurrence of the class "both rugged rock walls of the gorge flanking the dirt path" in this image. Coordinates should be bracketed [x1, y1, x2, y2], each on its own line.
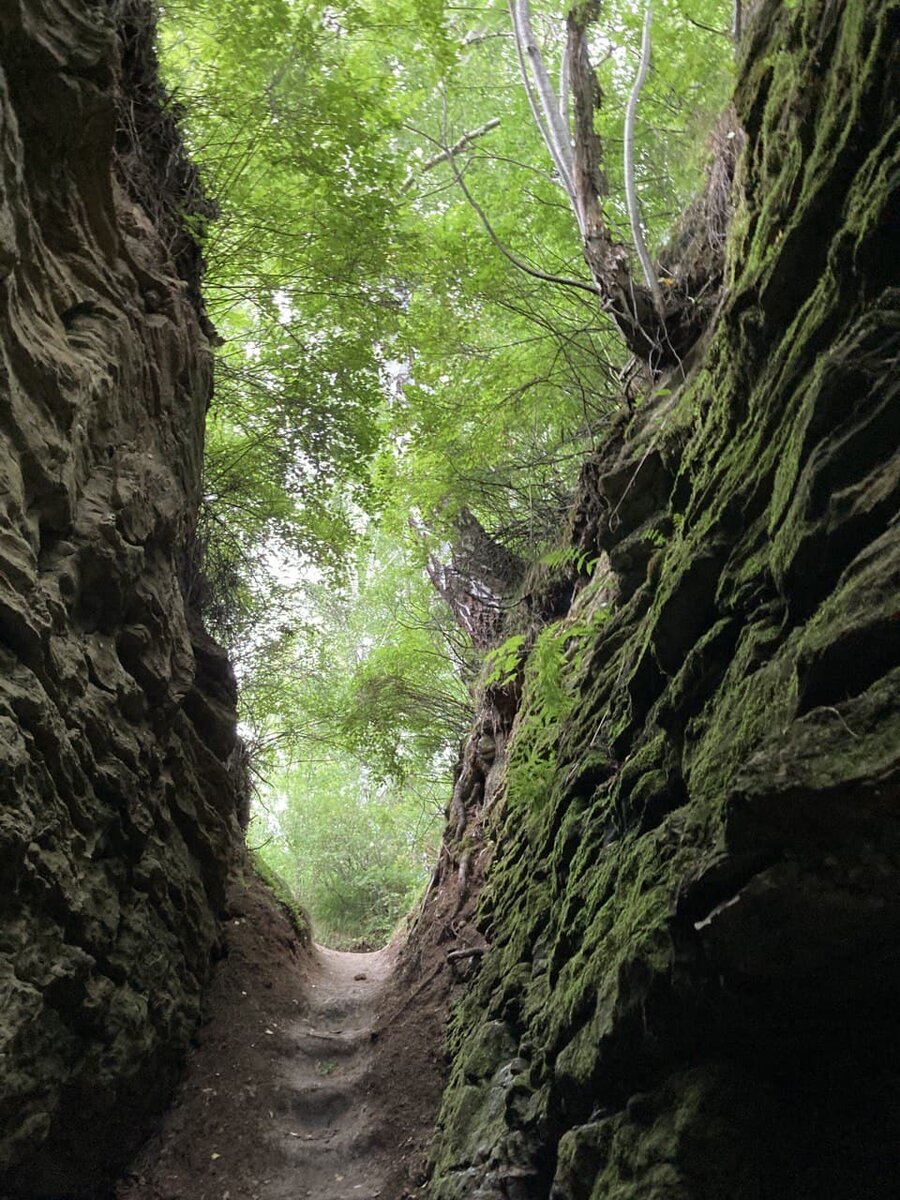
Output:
[0, 0, 900, 1200]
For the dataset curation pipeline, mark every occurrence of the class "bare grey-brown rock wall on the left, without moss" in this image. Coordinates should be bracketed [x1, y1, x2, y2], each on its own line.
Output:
[0, 0, 239, 1196]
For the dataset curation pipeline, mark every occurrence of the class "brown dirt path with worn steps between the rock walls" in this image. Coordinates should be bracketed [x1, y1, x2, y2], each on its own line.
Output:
[116, 881, 449, 1200]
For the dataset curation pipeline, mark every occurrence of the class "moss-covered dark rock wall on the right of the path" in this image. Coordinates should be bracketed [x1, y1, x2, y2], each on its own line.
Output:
[430, 0, 900, 1200]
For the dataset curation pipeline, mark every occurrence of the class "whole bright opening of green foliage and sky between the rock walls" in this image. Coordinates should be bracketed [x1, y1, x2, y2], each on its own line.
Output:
[161, 0, 732, 942]
